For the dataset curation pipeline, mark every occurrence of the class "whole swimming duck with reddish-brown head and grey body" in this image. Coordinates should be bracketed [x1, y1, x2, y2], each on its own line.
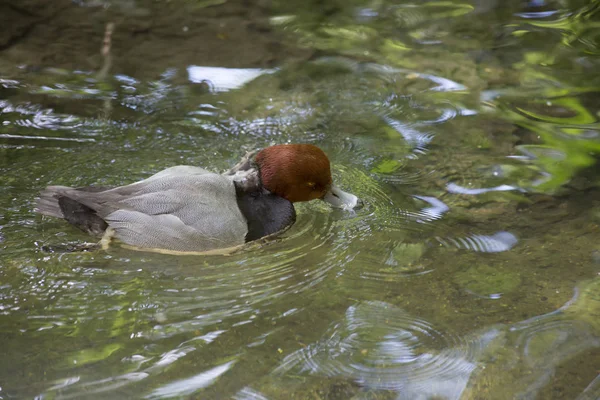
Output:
[35, 144, 362, 253]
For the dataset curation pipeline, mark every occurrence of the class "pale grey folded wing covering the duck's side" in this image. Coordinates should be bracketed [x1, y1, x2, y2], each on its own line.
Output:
[104, 174, 248, 251]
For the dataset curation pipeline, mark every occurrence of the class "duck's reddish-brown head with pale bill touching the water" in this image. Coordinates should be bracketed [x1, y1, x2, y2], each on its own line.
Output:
[246, 144, 360, 209]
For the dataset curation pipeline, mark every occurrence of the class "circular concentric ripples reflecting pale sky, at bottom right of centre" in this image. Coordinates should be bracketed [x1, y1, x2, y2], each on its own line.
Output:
[275, 302, 481, 399]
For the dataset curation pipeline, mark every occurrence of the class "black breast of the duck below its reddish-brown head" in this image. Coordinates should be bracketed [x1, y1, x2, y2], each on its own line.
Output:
[235, 182, 296, 242]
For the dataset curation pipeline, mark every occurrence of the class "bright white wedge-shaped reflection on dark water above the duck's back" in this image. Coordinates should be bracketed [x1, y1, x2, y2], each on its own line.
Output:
[187, 65, 277, 92]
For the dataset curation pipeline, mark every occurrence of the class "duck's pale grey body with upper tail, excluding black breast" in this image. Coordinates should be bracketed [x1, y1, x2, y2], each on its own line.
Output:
[37, 166, 248, 252]
